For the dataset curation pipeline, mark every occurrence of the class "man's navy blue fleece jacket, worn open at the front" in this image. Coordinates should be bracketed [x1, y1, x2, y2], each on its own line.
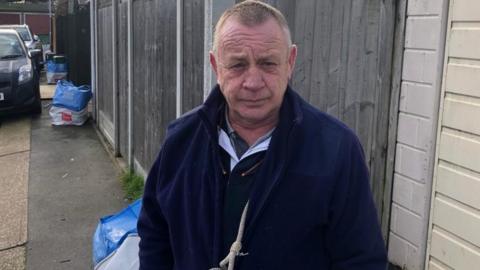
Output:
[138, 86, 386, 270]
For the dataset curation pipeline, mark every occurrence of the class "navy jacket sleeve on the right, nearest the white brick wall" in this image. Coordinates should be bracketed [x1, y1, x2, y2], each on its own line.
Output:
[326, 134, 387, 270]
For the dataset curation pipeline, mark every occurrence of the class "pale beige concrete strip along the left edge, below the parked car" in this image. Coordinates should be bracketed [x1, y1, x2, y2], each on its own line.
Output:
[0, 116, 30, 270]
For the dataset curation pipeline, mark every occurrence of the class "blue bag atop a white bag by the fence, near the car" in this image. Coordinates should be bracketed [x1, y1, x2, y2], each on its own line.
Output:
[52, 80, 92, 112]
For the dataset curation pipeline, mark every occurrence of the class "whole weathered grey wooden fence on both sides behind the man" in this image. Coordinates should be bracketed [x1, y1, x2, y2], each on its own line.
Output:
[94, 0, 398, 238]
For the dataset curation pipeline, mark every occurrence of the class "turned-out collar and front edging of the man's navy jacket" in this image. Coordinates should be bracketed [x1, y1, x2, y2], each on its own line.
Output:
[199, 85, 304, 261]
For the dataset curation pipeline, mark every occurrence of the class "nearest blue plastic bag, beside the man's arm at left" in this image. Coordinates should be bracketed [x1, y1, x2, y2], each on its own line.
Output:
[93, 199, 142, 265]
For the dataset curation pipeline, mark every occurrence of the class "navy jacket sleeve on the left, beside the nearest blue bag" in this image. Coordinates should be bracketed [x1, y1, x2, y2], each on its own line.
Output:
[137, 152, 173, 270]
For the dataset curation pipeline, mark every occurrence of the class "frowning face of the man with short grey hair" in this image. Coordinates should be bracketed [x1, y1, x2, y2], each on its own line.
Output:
[210, 18, 296, 127]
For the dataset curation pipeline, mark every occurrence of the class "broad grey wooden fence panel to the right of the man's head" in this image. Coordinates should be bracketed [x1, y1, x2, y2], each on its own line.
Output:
[260, 0, 395, 221]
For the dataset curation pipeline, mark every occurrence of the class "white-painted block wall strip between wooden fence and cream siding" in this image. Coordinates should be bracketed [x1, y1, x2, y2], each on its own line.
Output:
[388, 0, 447, 270]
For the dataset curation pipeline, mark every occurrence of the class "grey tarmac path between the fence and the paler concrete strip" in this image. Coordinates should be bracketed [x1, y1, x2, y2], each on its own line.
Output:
[27, 101, 127, 270]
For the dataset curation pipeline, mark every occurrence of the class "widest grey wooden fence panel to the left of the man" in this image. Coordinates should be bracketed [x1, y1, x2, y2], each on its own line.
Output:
[133, 0, 176, 170]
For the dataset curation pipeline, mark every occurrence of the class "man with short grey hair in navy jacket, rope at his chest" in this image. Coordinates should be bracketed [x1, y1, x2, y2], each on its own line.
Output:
[138, 1, 386, 270]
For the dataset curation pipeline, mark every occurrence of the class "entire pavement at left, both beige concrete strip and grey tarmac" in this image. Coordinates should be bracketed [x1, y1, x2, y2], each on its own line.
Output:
[0, 100, 127, 270]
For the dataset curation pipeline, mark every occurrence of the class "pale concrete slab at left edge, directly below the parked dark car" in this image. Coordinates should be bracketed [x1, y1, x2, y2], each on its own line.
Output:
[0, 116, 31, 156]
